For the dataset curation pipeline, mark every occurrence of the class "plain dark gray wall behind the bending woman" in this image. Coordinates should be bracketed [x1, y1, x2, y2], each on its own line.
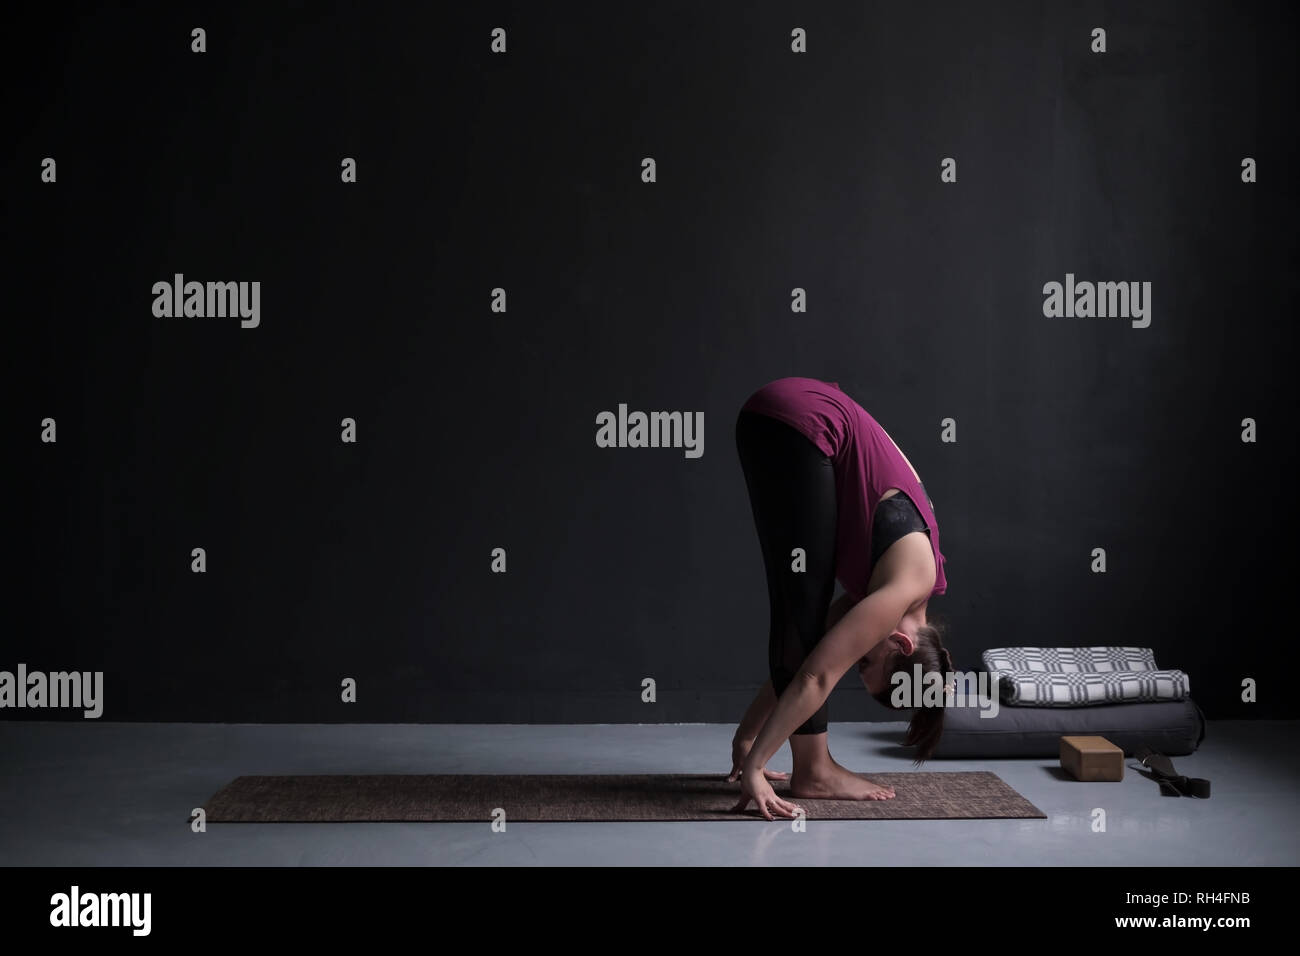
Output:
[0, 3, 1296, 722]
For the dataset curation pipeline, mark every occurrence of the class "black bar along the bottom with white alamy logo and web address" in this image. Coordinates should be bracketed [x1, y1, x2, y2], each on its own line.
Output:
[0, 866, 1296, 947]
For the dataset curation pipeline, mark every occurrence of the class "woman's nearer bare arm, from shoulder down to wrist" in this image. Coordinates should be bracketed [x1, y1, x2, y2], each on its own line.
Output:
[745, 576, 918, 777]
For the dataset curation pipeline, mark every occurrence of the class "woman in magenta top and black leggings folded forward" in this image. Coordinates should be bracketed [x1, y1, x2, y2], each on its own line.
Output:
[728, 377, 953, 819]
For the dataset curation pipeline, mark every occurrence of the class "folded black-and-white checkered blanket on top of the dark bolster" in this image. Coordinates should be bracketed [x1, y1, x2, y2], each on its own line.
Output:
[983, 648, 1191, 708]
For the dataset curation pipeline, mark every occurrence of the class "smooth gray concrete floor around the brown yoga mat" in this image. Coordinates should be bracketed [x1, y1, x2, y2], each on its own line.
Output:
[0, 721, 1300, 866]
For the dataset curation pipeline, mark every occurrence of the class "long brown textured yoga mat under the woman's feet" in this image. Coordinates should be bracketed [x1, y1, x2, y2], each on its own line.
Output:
[204, 770, 1047, 823]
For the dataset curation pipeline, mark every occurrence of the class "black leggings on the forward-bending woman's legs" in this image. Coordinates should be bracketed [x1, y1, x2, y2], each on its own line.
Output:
[736, 411, 837, 734]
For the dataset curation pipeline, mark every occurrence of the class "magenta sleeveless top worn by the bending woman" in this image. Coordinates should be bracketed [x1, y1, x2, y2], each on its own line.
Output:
[742, 377, 948, 601]
